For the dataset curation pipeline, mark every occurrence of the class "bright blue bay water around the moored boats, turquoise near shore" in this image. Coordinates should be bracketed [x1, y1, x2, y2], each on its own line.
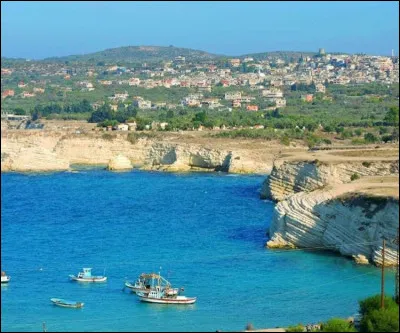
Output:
[1, 170, 394, 331]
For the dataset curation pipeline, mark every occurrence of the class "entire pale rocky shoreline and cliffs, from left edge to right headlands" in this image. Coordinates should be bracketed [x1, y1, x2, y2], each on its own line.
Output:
[1, 127, 399, 265]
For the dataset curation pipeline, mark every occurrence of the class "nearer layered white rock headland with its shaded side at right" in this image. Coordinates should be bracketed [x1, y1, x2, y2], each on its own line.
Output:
[267, 190, 399, 266]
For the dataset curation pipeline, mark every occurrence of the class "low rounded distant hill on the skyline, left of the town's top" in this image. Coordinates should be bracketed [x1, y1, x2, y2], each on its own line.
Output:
[44, 46, 225, 62]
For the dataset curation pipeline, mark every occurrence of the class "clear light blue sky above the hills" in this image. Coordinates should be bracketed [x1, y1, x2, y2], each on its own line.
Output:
[1, 1, 399, 59]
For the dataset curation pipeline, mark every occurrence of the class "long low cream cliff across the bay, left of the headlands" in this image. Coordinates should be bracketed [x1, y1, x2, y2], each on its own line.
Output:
[1, 131, 272, 173]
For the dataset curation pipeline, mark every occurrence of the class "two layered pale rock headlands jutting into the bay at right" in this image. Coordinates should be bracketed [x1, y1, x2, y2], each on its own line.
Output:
[261, 154, 399, 265]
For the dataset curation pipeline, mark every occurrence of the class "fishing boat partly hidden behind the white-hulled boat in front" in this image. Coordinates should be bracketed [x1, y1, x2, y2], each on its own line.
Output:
[125, 273, 179, 296]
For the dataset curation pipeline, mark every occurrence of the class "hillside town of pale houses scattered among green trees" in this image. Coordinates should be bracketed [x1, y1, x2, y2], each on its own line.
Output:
[1, 49, 399, 115]
